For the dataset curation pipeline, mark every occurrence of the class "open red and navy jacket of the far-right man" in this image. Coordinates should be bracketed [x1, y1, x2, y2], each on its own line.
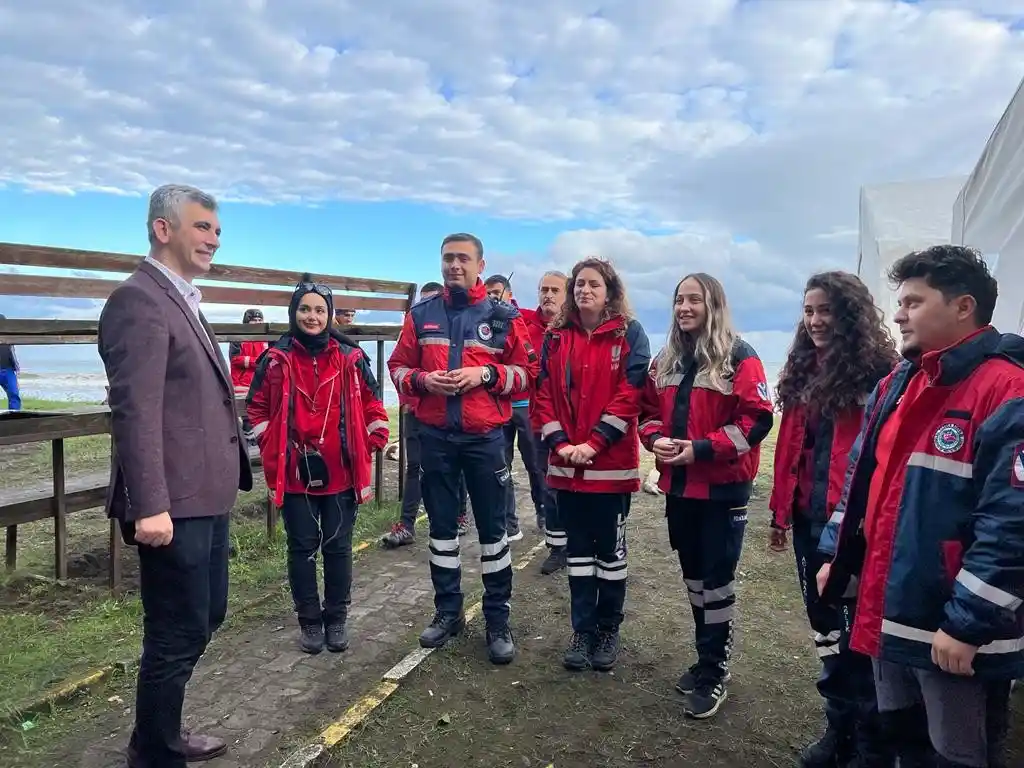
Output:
[818, 327, 1024, 679]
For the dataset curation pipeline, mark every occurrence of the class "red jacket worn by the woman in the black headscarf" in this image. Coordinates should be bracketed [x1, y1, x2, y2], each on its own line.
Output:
[246, 334, 389, 506]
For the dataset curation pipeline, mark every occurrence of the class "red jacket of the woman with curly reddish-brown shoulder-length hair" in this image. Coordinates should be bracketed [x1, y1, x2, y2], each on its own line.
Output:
[535, 316, 650, 494]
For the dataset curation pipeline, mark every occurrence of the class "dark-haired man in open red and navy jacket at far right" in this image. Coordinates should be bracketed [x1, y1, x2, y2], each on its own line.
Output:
[817, 245, 1024, 768]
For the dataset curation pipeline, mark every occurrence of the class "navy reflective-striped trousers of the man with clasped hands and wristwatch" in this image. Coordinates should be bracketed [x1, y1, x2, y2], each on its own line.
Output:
[420, 428, 512, 626]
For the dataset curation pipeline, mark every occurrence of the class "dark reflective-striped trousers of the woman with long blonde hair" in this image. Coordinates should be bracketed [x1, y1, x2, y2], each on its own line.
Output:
[666, 496, 746, 679]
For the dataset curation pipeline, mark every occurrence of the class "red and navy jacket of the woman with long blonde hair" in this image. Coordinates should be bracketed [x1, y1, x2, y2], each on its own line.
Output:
[640, 339, 774, 505]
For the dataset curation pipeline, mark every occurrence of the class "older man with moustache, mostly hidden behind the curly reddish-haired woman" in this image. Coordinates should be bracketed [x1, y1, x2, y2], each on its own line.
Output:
[520, 270, 568, 575]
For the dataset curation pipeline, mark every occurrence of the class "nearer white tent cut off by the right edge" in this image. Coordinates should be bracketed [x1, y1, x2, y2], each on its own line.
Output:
[952, 75, 1024, 333]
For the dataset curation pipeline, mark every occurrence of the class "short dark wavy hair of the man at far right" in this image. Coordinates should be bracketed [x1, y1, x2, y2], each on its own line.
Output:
[888, 245, 999, 326]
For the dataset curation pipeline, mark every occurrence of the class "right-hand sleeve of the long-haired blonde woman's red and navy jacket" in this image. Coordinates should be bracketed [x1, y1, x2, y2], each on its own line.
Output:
[693, 356, 775, 462]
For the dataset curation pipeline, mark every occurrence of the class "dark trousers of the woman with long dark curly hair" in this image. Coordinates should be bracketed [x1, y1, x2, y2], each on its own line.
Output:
[792, 512, 878, 741]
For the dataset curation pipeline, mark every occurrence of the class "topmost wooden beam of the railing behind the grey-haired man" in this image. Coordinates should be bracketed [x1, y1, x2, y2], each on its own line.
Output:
[0, 243, 415, 296]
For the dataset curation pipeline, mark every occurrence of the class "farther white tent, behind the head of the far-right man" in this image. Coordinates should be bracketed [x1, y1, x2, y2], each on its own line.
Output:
[857, 176, 965, 338]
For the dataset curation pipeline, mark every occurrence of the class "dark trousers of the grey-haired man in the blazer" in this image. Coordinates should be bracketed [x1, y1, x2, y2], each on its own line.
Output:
[129, 514, 228, 768]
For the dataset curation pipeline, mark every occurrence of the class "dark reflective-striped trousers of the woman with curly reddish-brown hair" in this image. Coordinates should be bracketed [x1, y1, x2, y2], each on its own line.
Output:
[558, 490, 632, 632]
